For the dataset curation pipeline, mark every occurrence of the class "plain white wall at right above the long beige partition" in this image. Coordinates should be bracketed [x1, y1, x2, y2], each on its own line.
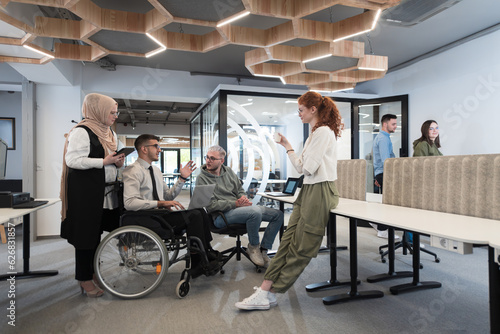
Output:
[356, 31, 500, 155]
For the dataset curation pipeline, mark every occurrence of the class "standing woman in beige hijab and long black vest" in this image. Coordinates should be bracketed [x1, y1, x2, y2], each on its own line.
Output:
[60, 93, 125, 297]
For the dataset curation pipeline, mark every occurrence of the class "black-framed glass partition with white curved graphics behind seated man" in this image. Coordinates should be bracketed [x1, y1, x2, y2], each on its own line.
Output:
[191, 90, 351, 203]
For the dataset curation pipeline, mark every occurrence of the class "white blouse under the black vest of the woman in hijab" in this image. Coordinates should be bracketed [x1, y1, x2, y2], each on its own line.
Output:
[64, 128, 123, 209]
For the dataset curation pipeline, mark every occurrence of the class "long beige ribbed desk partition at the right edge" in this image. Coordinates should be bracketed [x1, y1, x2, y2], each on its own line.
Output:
[383, 154, 500, 219]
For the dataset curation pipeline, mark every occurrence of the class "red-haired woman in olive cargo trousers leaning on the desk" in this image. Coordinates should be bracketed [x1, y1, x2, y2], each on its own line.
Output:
[236, 92, 343, 310]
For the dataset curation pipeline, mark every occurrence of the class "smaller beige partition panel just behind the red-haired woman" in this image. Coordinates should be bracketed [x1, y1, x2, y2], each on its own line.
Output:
[335, 159, 366, 201]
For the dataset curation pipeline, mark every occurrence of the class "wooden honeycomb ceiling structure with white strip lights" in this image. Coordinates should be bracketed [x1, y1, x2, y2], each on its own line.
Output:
[0, 0, 400, 87]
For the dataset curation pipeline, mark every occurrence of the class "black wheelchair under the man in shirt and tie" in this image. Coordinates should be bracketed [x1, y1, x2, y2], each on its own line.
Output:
[94, 209, 215, 299]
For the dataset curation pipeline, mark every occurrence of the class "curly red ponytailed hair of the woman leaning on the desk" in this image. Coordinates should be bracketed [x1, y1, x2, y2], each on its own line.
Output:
[299, 92, 344, 138]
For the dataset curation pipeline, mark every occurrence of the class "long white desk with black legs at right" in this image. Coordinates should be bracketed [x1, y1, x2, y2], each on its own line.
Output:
[314, 198, 500, 333]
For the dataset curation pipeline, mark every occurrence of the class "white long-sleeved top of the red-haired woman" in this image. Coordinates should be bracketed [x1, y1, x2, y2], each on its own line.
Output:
[288, 126, 337, 184]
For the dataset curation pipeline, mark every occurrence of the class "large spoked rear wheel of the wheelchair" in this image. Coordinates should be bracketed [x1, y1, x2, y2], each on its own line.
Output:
[94, 226, 169, 299]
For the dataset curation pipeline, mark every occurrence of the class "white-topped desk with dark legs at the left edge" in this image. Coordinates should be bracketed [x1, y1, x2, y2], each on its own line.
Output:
[0, 198, 60, 280]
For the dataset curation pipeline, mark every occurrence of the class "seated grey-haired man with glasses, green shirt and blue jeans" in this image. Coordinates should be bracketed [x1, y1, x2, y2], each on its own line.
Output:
[196, 145, 284, 267]
